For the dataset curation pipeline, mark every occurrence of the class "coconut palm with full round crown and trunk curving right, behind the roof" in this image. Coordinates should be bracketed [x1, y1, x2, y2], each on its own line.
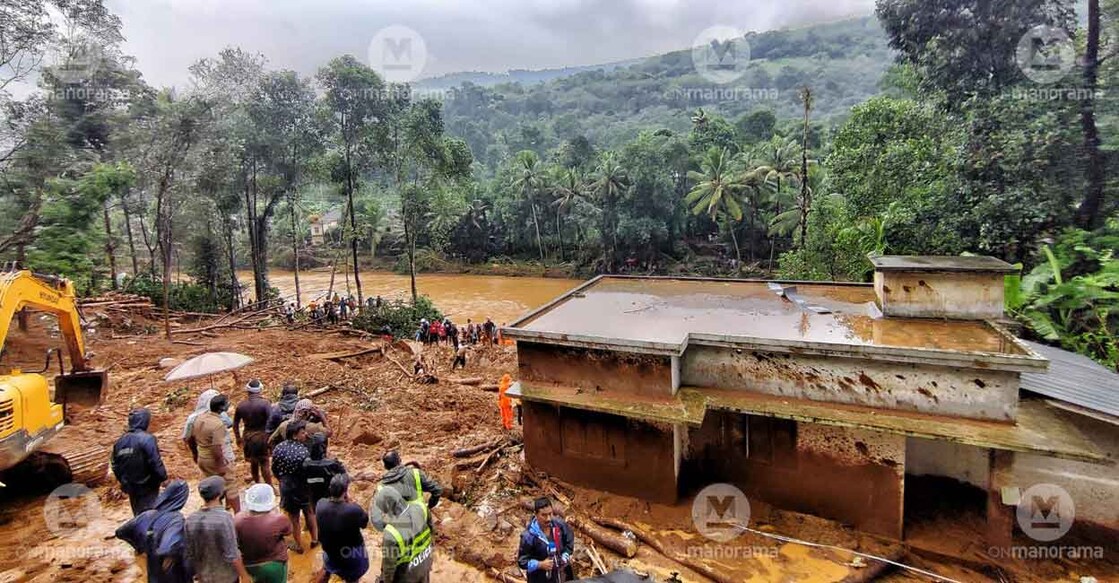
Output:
[684, 148, 743, 266]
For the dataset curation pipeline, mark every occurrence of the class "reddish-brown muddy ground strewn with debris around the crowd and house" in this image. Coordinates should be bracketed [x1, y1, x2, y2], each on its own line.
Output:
[0, 313, 1119, 583]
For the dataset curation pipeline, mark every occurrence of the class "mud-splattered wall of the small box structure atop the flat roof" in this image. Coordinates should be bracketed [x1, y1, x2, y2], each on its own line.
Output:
[874, 271, 1004, 320]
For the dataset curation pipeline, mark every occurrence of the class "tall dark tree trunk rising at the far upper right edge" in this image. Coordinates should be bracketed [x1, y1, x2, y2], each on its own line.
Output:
[1076, 0, 1106, 229]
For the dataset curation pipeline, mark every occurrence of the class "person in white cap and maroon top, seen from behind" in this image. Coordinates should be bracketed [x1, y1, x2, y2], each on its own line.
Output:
[233, 483, 291, 583]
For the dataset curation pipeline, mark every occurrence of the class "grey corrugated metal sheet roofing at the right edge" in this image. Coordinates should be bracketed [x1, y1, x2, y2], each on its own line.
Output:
[1022, 341, 1119, 417]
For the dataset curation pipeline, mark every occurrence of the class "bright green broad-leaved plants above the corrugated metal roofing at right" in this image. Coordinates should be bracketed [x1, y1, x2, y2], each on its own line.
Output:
[1006, 219, 1119, 369]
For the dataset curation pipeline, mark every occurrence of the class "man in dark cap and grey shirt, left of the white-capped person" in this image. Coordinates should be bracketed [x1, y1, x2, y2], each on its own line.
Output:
[186, 476, 250, 583]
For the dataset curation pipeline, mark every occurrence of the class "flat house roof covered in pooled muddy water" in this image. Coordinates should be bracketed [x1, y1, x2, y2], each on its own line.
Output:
[505, 276, 1046, 370]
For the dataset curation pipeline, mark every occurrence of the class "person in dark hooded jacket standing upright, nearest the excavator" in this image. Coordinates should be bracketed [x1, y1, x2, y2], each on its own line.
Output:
[111, 408, 167, 516]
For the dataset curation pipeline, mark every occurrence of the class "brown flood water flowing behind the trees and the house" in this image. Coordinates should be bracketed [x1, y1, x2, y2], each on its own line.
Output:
[237, 270, 582, 325]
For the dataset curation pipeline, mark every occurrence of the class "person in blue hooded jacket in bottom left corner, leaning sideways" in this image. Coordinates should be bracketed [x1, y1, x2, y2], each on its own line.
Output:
[116, 480, 194, 583]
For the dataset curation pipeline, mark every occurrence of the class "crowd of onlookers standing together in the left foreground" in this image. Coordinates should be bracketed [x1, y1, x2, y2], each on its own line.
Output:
[111, 379, 442, 583]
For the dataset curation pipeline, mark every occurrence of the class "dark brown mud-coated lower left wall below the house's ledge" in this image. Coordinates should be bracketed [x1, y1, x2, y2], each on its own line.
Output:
[524, 402, 677, 504]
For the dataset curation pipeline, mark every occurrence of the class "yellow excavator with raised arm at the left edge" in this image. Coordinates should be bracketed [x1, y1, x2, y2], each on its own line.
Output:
[0, 265, 109, 489]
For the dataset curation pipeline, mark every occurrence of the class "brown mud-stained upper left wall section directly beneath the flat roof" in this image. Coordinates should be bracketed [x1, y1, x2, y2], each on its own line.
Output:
[517, 341, 673, 395]
